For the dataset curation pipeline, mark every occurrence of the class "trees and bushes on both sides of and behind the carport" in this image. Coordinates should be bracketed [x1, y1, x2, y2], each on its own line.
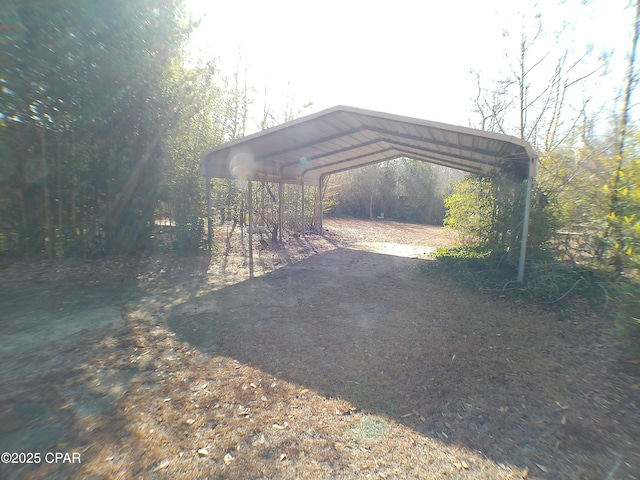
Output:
[0, 0, 640, 280]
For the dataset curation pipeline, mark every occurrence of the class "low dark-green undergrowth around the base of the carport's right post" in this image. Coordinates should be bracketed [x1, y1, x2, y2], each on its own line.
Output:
[421, 245, 640, 359]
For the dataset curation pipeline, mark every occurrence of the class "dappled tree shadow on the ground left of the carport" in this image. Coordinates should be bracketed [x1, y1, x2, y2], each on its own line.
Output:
[0, 255, 211, 472]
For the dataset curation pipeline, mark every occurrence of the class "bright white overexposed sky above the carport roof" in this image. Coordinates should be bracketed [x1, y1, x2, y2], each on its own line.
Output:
[187, 0, 634, 133]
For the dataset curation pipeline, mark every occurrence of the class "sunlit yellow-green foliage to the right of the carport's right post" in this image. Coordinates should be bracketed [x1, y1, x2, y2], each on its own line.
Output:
[538, 137, 640, 275]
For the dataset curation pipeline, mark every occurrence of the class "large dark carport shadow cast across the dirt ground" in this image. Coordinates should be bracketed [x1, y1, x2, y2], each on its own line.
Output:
[169, 248, 632, 476]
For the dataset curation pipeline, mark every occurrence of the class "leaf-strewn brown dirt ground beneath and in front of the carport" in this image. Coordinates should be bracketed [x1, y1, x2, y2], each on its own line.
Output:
[0, 220, 640, 480]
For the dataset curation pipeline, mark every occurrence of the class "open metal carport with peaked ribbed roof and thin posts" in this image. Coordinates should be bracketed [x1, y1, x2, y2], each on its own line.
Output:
[200, 106, 538, 282]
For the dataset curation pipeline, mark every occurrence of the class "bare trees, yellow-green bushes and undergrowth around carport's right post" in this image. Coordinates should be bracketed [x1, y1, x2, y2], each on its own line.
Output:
[438, 1, 640, 356]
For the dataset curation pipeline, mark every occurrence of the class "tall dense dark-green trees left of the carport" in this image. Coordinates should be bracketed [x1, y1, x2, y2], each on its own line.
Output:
[0, 0, 191, 256]
